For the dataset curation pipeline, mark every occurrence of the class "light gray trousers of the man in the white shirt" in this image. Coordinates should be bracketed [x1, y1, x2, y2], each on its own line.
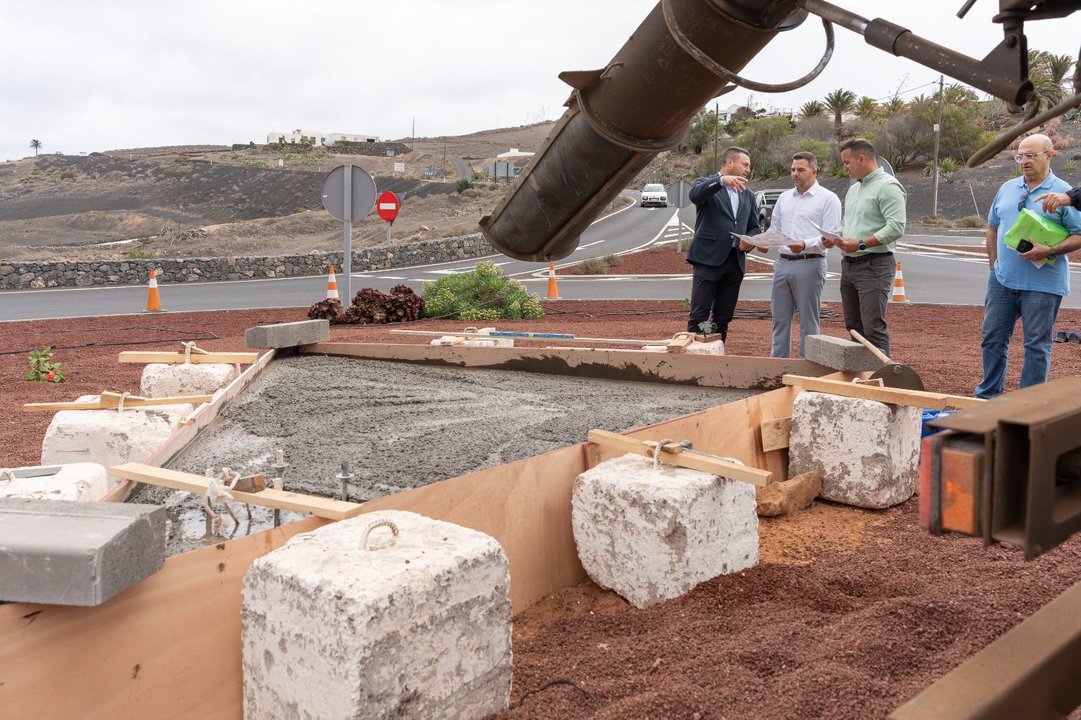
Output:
[770, 257, 826, 358]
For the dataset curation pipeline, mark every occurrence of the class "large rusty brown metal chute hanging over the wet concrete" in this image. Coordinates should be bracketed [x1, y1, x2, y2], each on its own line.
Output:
[480, 0, 806, 262]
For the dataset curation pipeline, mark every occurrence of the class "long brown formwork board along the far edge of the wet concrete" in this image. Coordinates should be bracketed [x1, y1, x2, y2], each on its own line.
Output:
[301, 341, 833, 390]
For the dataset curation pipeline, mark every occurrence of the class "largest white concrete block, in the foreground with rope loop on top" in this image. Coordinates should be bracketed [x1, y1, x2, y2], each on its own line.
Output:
[242, 503, 511, 720]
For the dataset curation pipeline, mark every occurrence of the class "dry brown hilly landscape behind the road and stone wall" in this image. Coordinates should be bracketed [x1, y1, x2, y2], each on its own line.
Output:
[0, 122, 1081, 262]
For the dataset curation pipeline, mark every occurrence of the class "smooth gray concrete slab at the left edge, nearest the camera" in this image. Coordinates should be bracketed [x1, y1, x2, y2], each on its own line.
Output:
[0, 498, 166, 605]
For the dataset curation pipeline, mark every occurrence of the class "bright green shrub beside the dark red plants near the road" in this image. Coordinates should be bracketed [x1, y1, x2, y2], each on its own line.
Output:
[421, 261, 544, 320]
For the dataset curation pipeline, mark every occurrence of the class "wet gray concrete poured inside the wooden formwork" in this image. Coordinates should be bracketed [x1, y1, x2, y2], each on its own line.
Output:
[132, 356, 751, 554]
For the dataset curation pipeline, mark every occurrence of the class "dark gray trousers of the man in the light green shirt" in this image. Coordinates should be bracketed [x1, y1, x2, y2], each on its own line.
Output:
[841, 253, 897, 355]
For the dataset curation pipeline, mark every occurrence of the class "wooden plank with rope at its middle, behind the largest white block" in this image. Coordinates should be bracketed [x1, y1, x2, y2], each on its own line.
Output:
[109, 463, 361, 520]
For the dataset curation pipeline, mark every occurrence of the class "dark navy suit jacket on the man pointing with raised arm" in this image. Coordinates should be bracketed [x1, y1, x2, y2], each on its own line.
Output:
[686, 174, 762, 270]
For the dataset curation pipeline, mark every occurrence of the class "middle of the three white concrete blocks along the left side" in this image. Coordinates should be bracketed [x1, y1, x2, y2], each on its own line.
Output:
[41, 395, 195, 490]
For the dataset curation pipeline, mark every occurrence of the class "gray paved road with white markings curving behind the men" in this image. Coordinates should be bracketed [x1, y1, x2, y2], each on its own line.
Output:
[6, 196, 1081, 320]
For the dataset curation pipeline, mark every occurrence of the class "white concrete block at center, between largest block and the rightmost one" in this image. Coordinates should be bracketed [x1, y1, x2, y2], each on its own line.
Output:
[571, 454, 758, 608]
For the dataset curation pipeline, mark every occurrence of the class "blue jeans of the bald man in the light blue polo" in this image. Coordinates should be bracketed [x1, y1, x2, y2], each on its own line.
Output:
[976, 271, 1063, 398]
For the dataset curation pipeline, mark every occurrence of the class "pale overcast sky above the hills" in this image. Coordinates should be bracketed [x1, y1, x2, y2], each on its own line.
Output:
[0, 0, 1081, 160]
